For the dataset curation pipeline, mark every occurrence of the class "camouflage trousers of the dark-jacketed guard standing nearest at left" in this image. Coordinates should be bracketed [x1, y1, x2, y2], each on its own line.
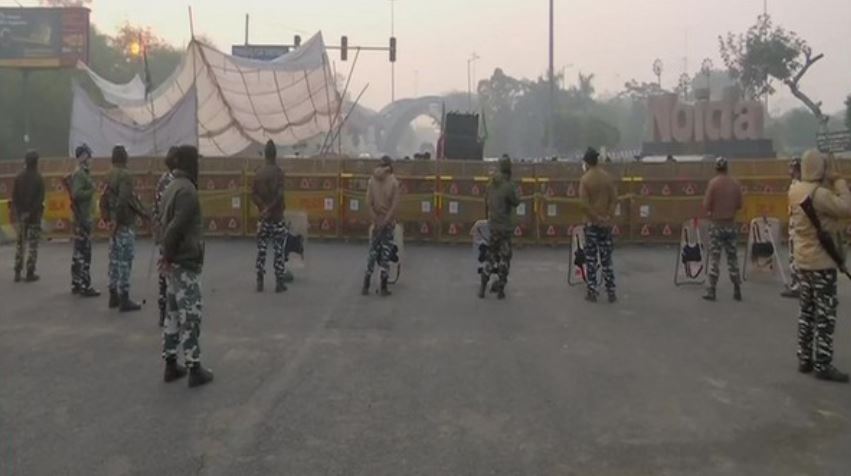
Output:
[163, 265, 202, 367]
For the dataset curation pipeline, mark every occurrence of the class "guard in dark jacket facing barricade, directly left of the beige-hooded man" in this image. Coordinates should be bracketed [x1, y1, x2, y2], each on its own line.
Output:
[251, 140, 287, 293]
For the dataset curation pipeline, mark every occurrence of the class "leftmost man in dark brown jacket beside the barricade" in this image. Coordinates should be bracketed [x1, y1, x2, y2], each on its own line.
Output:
[12, 150, 44, 283]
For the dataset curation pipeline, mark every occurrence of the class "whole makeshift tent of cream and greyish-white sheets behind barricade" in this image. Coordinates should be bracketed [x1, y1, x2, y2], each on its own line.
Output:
[69, 33, 340, 156]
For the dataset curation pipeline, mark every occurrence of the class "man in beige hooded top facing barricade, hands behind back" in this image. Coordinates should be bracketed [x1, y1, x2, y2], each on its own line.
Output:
[361, 156, 400, 296]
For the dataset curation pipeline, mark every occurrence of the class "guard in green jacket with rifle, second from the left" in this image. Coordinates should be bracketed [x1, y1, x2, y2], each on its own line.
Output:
[70, 144, 100, 297]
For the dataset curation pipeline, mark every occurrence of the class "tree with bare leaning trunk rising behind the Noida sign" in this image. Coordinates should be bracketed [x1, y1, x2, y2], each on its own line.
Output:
[718, 15, 829, 127]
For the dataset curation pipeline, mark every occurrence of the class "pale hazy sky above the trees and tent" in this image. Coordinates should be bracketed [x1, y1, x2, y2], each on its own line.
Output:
[20, 0, 851, 112]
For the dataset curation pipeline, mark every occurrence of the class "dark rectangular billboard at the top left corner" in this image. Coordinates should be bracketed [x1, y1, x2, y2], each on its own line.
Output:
[0, 8, 89, 68]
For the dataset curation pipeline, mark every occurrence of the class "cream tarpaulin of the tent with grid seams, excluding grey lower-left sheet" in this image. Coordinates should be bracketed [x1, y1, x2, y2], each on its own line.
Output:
[72, 34, 338, 156]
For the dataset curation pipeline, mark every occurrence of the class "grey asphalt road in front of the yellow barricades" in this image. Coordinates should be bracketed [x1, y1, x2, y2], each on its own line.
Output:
[0, 241, 851, 476]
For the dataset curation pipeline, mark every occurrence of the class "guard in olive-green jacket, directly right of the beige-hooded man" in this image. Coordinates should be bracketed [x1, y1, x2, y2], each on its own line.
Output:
[479, 155, 520, 299]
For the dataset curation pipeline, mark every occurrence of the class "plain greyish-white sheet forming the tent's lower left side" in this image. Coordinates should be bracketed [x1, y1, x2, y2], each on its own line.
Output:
[69, 82, 197, 157]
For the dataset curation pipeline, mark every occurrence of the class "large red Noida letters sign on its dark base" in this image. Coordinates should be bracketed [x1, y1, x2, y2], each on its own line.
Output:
[642, 94, 776, 158]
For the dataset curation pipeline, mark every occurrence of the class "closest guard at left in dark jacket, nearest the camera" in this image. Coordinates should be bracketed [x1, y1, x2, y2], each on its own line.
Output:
[159, 145, 213, 387]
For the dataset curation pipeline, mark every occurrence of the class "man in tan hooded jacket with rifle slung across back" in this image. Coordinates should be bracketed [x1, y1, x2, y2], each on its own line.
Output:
[789, 150, 851, 382]
